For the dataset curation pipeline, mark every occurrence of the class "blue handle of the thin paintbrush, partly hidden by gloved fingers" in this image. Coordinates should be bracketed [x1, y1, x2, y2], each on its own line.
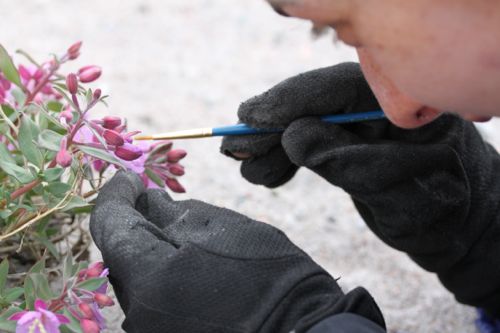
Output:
[212, 110, 385, 136]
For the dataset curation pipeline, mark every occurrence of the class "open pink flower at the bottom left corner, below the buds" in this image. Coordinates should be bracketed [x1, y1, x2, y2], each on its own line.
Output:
[9, 299, 69, 333]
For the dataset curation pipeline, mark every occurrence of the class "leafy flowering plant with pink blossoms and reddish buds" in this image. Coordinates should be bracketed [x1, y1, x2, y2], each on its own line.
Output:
[0, 42, 186, 333]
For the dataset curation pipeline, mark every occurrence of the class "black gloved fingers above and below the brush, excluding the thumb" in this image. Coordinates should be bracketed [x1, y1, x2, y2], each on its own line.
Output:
[221, 63, 380, 187]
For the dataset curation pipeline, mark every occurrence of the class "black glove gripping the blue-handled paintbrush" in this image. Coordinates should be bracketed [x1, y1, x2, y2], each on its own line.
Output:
[222, 64, 500, 317]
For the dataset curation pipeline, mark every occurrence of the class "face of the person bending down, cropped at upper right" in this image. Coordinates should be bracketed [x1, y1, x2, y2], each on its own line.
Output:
[268, 0, 500, 128]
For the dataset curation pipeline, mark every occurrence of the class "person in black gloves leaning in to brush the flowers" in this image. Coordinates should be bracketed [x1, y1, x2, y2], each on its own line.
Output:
[90, 0, 500, 333]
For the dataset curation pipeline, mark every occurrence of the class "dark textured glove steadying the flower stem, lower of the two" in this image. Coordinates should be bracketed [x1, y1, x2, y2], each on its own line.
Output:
[90, 172, 384, 333]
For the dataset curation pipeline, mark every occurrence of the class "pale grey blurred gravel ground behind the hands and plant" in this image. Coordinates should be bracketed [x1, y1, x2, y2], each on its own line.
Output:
[0, 0, 500, 333]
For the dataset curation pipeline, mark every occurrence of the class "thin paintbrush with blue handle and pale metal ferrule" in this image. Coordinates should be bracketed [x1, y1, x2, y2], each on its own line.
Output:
[134, 110, 385, 140]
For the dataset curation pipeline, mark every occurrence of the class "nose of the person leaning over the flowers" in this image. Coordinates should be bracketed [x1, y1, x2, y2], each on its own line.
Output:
[358, 49, 442, 128]
